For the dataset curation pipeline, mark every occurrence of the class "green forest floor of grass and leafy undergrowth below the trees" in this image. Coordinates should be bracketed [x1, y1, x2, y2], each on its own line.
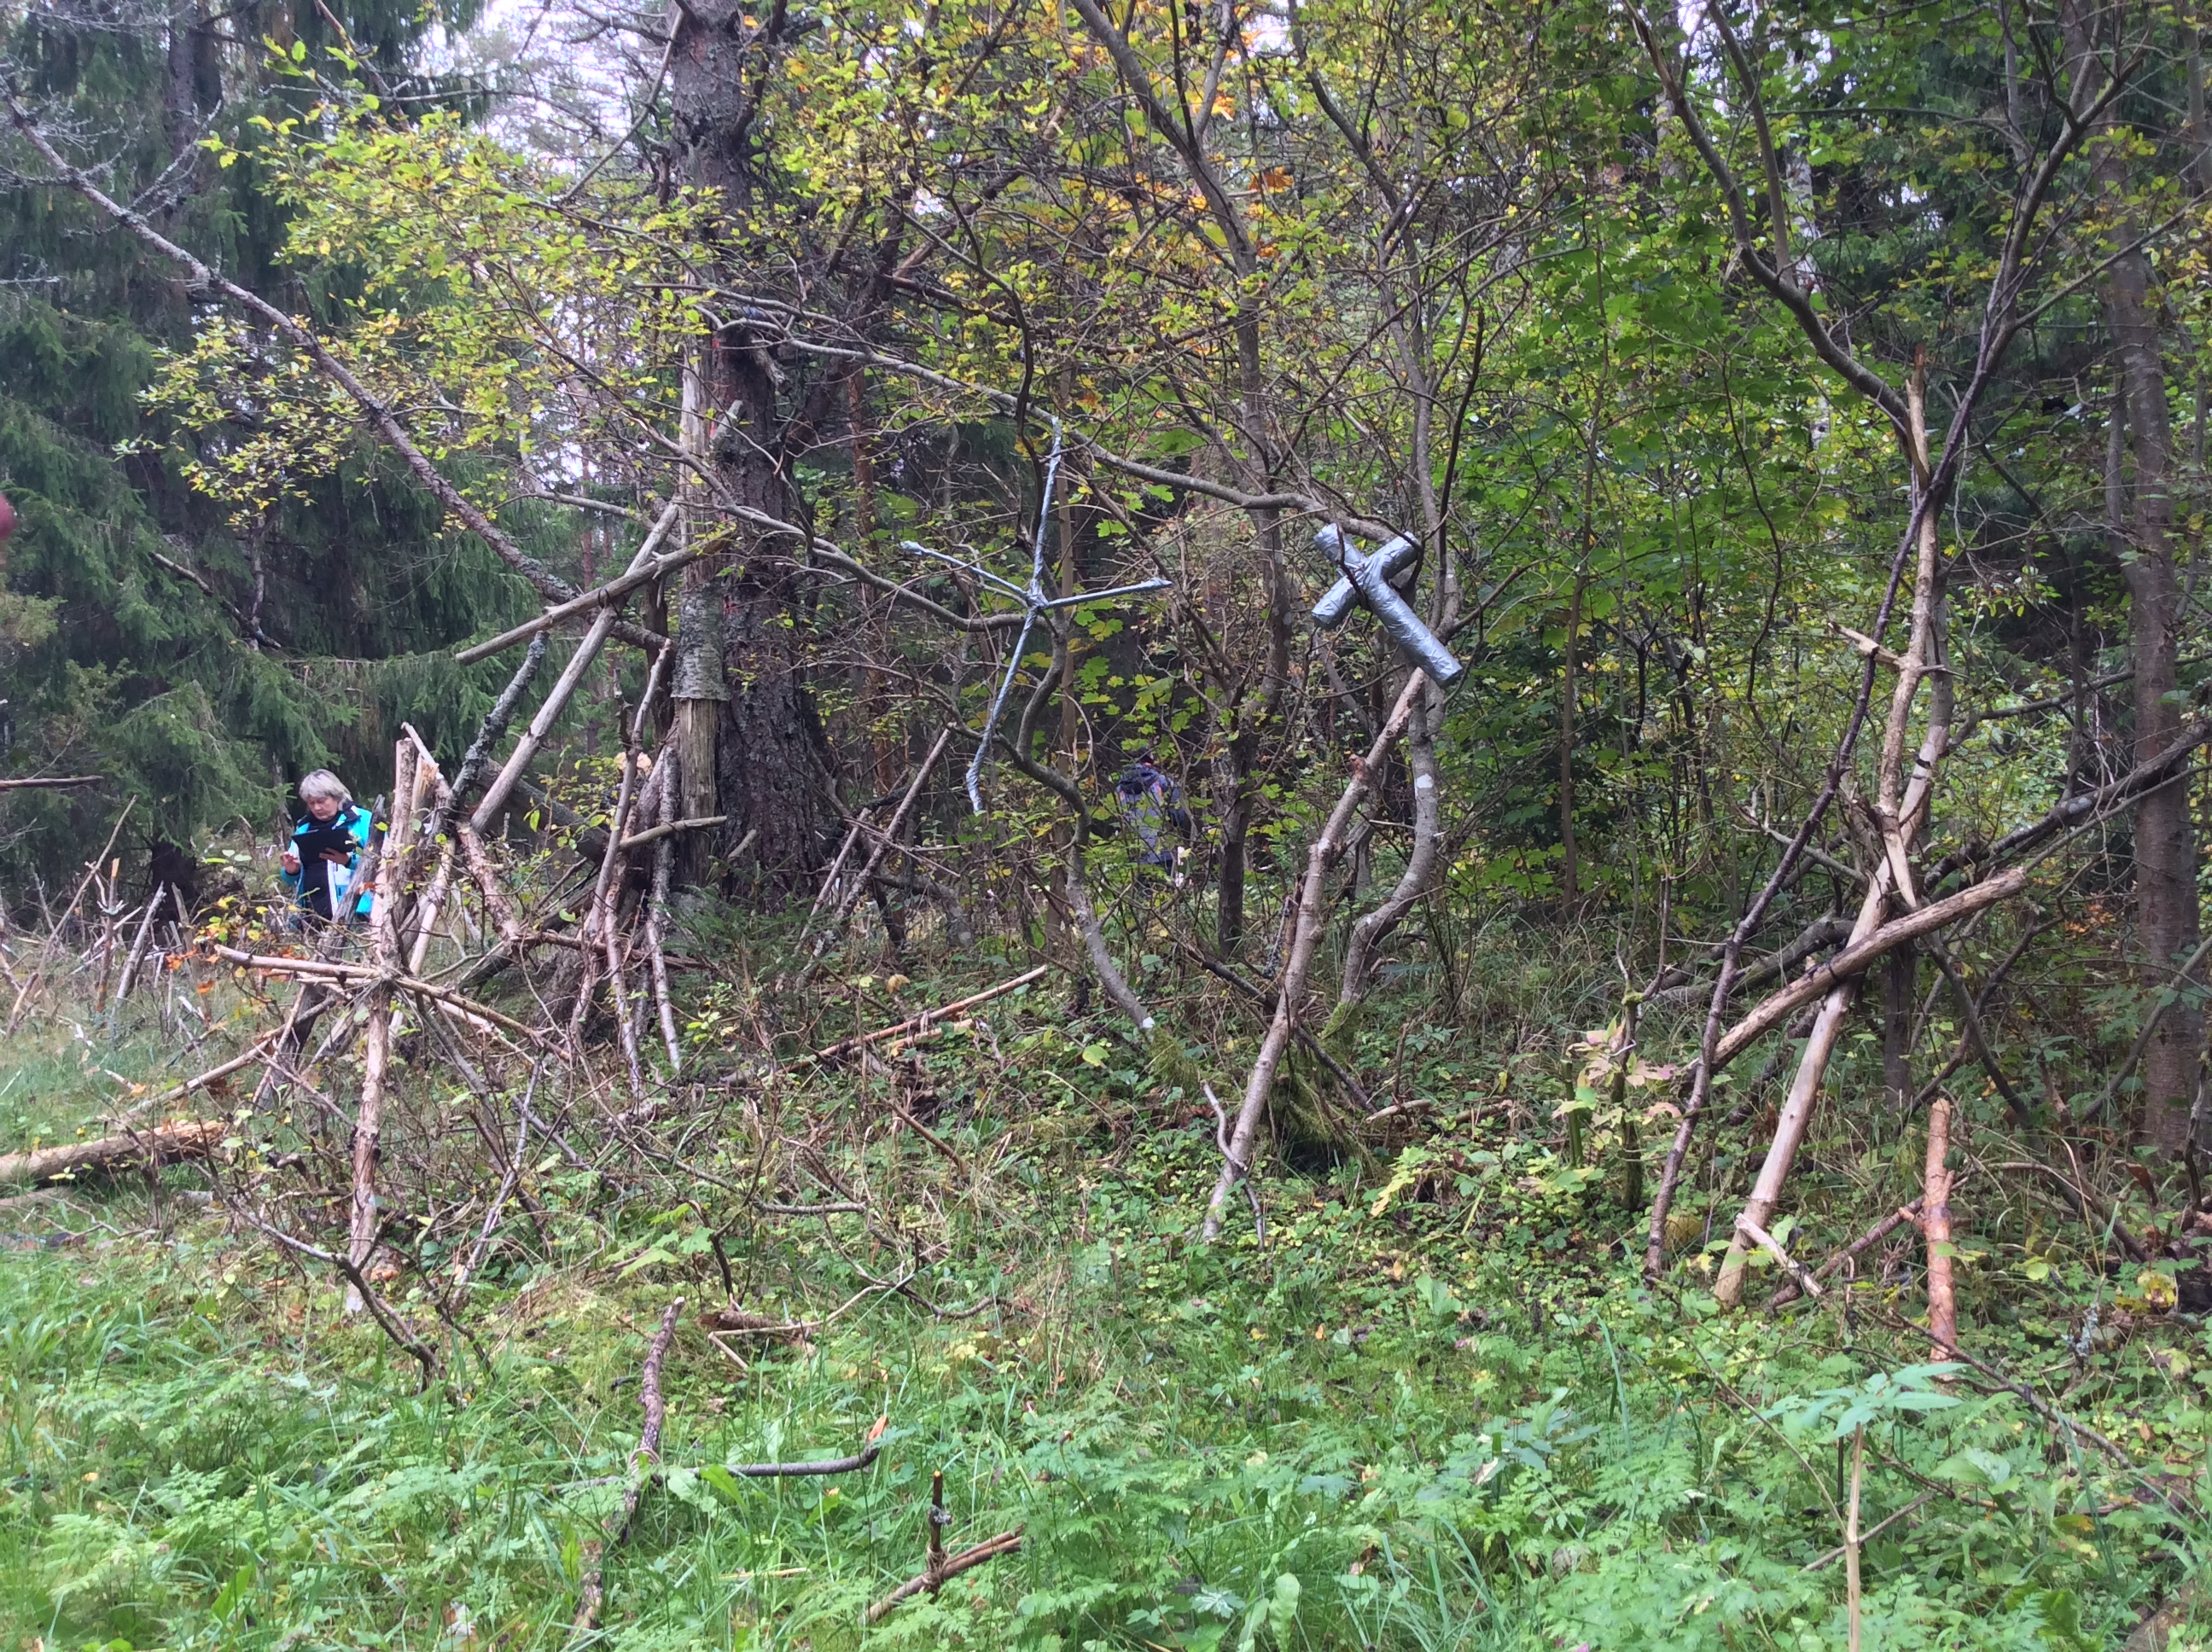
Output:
[0, 955, 2212, 1652]
